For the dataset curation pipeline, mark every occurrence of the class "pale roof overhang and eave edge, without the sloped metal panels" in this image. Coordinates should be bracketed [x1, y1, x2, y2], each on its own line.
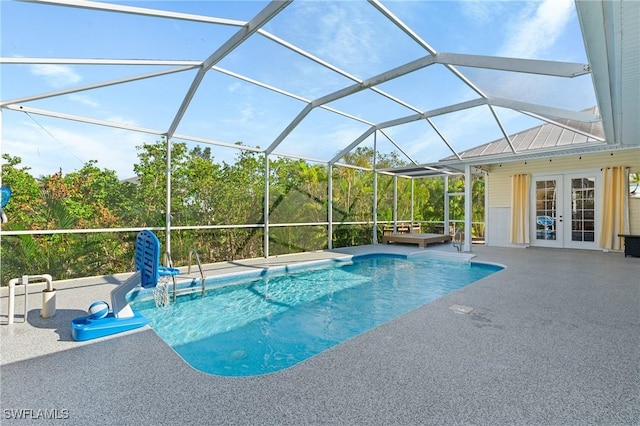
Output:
[385, 0, 640, 177]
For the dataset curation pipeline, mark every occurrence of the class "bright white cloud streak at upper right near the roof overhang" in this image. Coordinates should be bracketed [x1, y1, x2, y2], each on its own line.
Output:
[499, 0, 573, 58]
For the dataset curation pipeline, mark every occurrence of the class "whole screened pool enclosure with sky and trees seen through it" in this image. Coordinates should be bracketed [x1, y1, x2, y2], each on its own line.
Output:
[0, 0, 640, 284]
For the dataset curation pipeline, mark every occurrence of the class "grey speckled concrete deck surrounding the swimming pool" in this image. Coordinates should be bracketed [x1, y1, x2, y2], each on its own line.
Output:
[0, 245, 640, 425]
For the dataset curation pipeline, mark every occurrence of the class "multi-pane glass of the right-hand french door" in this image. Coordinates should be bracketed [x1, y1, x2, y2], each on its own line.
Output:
[571, 178, 596, 242]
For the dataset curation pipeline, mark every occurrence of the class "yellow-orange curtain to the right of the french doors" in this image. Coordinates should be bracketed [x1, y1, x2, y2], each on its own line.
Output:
[598, 166, 629, 250]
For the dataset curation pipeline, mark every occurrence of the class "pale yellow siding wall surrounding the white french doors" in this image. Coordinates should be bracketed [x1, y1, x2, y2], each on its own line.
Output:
[483, 149, 640, 250]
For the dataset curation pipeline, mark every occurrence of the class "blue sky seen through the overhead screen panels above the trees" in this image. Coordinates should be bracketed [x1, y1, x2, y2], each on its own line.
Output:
[0, 0, 595, 178]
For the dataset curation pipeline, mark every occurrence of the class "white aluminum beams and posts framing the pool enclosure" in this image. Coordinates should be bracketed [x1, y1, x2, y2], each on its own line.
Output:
[0, 0, 640, 256]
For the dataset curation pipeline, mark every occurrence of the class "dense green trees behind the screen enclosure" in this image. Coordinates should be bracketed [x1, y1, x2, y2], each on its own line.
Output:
[0, 140, 484, 285]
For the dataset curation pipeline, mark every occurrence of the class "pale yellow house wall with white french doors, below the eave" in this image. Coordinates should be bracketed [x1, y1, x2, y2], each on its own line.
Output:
[482, 148, 640, 249]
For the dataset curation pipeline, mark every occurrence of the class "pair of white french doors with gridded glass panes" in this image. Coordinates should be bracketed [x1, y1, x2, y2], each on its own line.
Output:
[530, 172, 600, 249]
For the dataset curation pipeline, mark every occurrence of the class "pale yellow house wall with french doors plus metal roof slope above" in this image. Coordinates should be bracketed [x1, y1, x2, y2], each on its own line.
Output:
[443, 108, 640, 250]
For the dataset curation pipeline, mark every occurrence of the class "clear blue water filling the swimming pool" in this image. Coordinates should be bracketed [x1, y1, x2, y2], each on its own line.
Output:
[131, 255, 502, 376]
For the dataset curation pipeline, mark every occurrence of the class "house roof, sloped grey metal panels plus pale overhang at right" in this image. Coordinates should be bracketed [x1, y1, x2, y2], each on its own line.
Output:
[384, 0, 640, 176]
